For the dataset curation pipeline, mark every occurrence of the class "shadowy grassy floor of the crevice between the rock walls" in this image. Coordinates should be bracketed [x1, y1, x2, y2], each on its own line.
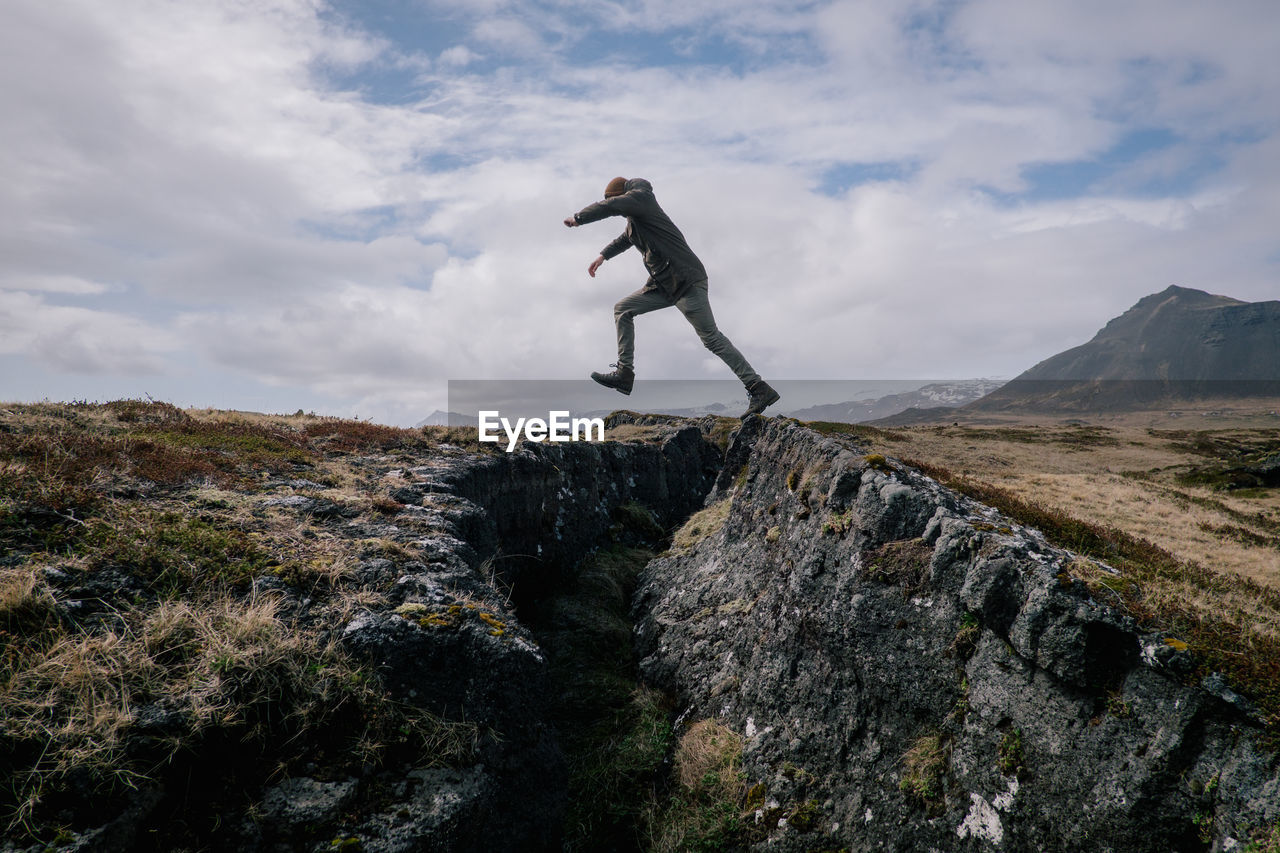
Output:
[525, 522, 783, 853]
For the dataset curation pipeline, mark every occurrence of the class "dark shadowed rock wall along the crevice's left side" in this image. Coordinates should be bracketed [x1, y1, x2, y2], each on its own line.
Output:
[339, 424, 719, 853]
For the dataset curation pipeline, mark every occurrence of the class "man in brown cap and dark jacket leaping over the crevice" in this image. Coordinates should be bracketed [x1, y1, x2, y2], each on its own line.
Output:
[564, 178, 778, 418]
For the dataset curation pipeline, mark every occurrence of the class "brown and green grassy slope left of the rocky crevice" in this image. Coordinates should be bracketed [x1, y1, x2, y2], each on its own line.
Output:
[0, 401, 476, 847]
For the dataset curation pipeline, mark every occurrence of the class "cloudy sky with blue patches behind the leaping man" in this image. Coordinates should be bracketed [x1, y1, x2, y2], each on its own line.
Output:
[0, 0, 1280, 424]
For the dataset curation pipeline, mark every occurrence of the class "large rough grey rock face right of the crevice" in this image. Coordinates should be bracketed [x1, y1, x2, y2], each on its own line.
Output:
[635, 420, 1280, 853]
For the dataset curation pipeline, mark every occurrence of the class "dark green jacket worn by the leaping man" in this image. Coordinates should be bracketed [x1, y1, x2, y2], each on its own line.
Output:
[573, 178, 707, 298]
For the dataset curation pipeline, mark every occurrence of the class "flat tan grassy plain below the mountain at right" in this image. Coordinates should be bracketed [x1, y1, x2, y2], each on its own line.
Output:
[874, 415, 1280, 588]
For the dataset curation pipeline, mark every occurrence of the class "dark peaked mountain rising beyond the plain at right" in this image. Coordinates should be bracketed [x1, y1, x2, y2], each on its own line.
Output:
[965, 286, 1280, 412]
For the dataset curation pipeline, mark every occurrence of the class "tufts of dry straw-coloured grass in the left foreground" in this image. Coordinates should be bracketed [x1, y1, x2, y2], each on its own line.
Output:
[0, 596, 477, 830]
